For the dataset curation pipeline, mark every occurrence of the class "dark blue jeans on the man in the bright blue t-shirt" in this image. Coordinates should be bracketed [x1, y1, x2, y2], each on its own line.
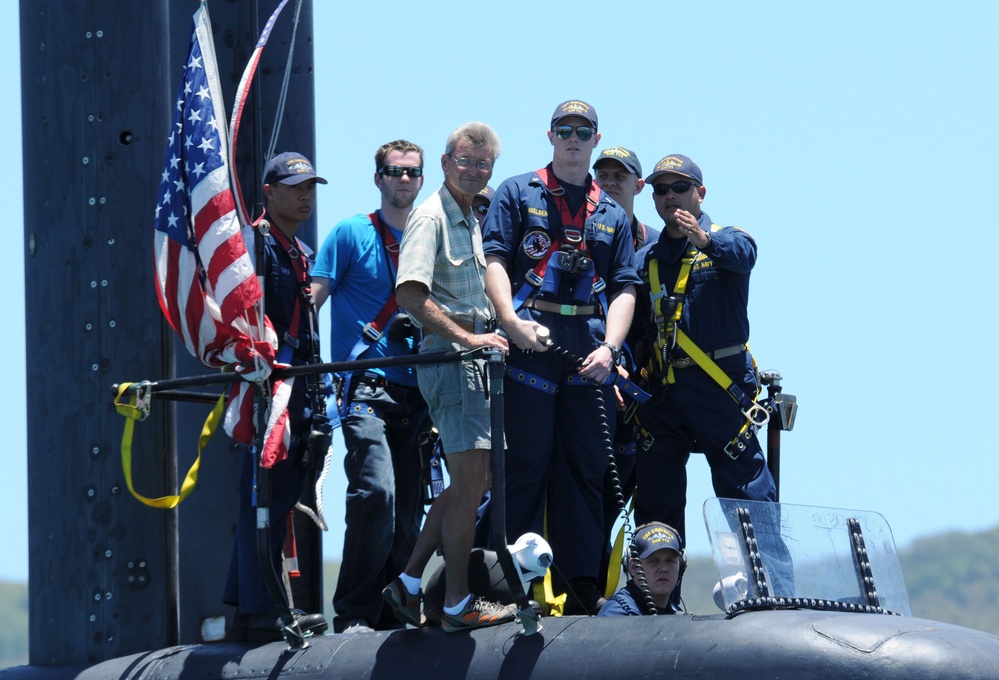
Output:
[333, 379, 431, 632]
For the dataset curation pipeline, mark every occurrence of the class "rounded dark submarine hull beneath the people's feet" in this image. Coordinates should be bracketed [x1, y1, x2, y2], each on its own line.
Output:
[0, 610, 999, 680]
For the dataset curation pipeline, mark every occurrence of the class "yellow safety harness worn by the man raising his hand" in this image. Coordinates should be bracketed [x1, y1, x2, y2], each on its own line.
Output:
[647, 224, 771, 460]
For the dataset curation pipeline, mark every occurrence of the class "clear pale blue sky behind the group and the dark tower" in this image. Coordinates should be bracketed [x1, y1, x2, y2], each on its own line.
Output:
[0, 0, 999, 580]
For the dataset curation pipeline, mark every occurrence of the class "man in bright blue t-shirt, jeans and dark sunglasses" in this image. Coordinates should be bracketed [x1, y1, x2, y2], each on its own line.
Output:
[312, 139, 430, 633]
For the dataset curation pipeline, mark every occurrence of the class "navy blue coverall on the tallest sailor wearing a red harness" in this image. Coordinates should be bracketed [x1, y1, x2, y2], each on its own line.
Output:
[482, 165, 639, 580]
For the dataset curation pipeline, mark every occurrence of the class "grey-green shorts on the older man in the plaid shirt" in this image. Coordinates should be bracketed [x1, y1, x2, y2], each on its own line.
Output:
[416, 334, 492, 454]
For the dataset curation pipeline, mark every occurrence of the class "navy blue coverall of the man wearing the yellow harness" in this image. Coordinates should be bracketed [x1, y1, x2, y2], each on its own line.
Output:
[630, 213, 776, 548]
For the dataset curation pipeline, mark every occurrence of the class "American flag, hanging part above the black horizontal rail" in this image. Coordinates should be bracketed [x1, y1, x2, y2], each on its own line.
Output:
[154, 8, 273, 368]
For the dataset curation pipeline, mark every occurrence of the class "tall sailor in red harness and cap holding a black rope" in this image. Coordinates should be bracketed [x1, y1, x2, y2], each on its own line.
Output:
[482, 101, 639, 614]
